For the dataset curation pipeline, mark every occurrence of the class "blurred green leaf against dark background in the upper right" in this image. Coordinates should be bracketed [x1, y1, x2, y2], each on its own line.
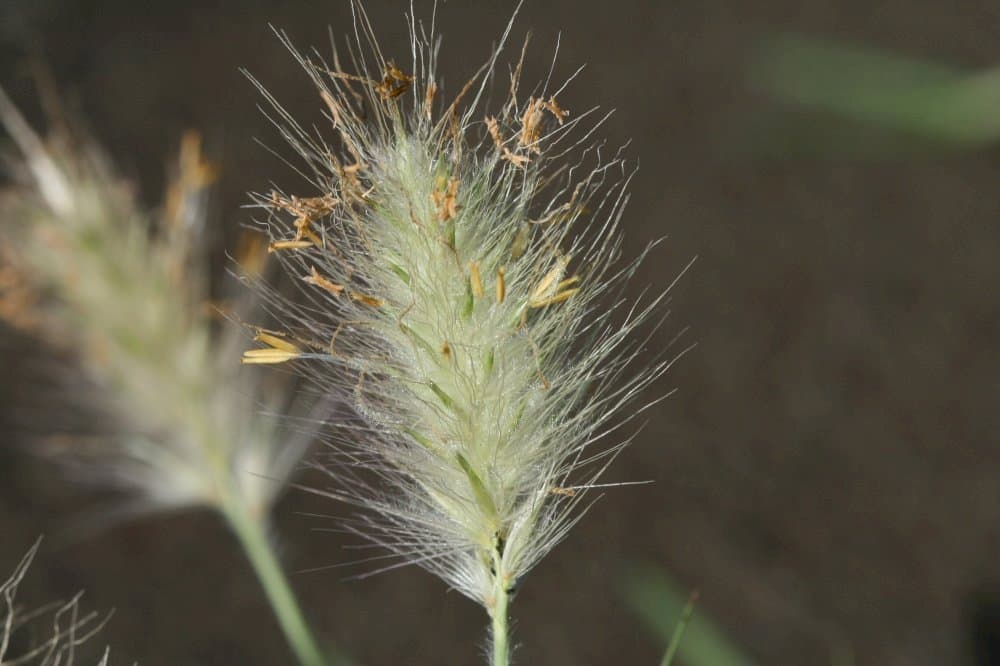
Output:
[748, 33, 1000, 146]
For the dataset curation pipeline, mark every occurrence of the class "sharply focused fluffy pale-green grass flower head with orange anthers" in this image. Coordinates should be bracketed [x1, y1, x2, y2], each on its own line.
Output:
[244, 5, 692, 632]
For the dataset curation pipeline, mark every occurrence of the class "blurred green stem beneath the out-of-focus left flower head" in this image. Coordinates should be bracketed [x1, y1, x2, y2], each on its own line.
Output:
[223, 500, 327, 666]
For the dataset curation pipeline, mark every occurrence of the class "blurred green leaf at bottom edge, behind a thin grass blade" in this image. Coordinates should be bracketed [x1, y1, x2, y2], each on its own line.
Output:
[624, 565, 753, 666]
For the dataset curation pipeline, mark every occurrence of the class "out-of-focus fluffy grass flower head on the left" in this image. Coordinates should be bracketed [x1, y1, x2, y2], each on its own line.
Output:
[0, 90, 307, 522]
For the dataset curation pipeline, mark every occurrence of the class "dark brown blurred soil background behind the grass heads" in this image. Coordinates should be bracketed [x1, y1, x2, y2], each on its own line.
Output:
[0, 0, 1000, 666]
